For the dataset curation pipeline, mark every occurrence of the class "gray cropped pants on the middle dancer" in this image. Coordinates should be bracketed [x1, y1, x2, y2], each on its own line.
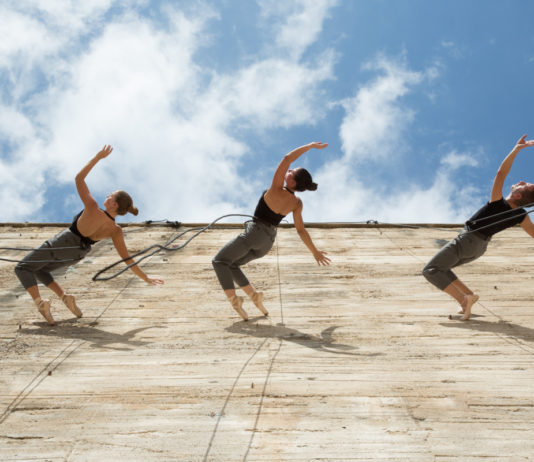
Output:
[212, 221, 276, 290]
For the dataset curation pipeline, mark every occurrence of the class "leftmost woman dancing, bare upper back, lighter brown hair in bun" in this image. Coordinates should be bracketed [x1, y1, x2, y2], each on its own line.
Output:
[15, 146, 163, 326]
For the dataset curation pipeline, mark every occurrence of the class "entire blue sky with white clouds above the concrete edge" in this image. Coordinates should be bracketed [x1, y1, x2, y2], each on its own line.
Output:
[0, 0, 534, 222]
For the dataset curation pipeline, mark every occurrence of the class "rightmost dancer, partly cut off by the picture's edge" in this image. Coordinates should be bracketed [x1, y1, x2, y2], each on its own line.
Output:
[423, 135, 534, 321]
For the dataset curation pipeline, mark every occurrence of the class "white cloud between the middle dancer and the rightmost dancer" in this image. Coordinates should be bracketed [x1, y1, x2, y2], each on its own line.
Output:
[304, 57, 480, 223]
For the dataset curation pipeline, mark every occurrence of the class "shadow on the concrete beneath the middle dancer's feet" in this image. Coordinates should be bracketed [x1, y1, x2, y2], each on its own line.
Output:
[225, 316, 382, 356]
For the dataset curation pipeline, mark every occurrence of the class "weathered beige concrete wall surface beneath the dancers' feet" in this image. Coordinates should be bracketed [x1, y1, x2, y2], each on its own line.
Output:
[0, 222, 534, 462]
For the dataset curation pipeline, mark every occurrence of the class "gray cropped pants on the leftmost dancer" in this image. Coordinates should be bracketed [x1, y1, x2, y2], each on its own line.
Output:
[15, 229, 91, 289]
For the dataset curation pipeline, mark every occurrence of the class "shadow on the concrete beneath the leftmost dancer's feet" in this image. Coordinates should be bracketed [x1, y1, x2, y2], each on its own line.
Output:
[19, 318, 157, 351]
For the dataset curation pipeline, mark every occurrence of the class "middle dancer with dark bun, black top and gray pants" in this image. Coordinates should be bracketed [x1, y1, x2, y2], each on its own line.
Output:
[212, 142, 330, 321]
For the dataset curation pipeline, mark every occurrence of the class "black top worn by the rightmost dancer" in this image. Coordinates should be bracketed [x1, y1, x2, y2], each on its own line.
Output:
[465, 198, 527, 237]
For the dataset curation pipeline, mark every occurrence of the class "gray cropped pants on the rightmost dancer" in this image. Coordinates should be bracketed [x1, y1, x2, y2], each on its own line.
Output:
[423, 230, 490, 290]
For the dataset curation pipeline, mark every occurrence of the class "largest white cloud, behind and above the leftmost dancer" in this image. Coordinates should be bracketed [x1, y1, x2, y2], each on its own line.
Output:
[0, 2, 334, 221]
